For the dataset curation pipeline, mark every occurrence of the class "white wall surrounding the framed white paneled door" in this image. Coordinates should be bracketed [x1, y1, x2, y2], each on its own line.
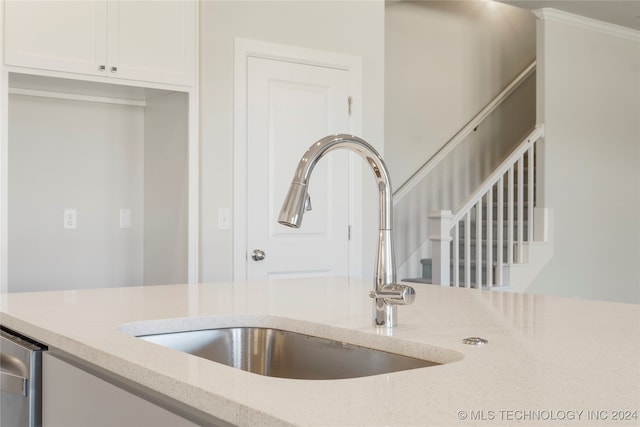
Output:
[199, 0, 384, 282]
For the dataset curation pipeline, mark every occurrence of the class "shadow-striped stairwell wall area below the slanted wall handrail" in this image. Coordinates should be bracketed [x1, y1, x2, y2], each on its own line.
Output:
[394, 74, 536, 278]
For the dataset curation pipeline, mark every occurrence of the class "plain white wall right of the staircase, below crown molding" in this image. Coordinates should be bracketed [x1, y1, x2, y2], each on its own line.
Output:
[527, 10, 640, 303]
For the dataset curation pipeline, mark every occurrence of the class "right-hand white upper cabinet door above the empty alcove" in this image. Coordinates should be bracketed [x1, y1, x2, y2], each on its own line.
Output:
[107, 0, 196, 86]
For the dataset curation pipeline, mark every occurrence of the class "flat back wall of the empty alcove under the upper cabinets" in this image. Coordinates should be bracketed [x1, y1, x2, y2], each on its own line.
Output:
[8, 95, 144, 291]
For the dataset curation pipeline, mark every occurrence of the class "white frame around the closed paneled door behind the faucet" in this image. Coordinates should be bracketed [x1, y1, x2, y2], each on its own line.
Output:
[232, 38, 362, 280]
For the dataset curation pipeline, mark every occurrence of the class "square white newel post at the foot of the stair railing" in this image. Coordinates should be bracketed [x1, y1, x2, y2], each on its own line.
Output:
[429, 211, 453, 286]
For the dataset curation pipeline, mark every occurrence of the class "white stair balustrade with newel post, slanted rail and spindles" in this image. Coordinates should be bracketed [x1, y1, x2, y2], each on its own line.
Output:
[408, 125, 544, 289]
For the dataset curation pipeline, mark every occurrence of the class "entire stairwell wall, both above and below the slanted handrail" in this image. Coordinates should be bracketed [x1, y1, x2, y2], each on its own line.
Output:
[385, 1, 536, 278]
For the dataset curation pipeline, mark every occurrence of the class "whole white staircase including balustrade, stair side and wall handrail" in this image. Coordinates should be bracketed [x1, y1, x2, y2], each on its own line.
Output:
[393, 61, 553, 291]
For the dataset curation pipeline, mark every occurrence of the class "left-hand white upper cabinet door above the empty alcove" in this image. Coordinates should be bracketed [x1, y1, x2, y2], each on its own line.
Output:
[4, 0, 107, 75]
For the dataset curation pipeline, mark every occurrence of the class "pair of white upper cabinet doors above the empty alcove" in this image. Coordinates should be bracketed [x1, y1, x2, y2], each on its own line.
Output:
[4, 0, 196, 86]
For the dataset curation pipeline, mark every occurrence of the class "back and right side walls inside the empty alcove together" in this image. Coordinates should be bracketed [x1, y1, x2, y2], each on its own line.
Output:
[7, 88, 188, 292]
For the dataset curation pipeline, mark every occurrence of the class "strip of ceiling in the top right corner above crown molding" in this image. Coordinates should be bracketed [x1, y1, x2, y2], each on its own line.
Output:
[498, 0, 640, 31]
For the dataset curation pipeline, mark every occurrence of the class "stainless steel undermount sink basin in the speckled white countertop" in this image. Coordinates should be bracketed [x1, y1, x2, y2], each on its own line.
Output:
[138, 327, 439, 380]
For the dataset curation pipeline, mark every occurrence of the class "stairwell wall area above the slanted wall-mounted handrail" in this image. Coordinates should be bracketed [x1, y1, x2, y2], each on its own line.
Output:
[385, 1, 536, 187]
